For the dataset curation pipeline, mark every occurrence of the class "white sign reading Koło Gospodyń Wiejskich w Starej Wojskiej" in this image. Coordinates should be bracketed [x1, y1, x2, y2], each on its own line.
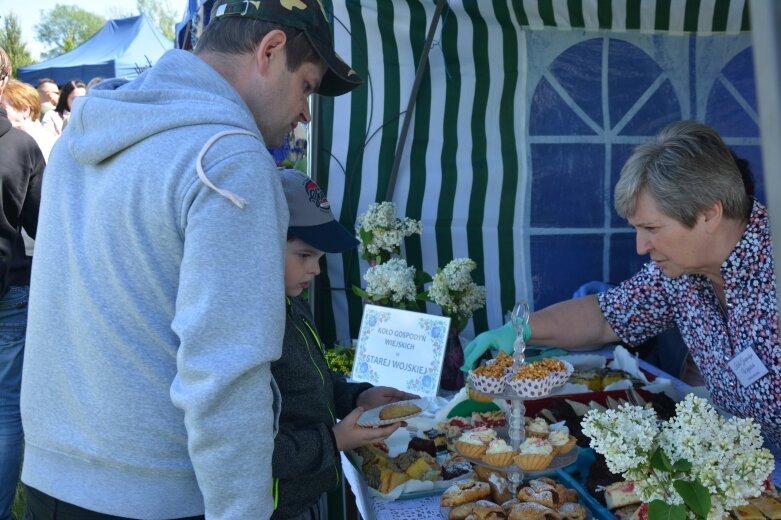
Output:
[352, 305, 450, 397]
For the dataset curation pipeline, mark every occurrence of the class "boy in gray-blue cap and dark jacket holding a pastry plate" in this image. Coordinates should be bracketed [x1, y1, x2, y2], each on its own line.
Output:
[271, 170, 418, 520]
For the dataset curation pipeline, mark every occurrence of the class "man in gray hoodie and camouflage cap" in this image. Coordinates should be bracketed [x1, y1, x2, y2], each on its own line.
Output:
[21, 0, 361, 520]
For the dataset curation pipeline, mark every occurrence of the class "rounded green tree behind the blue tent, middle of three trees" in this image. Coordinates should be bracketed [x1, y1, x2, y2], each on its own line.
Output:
[35, 4, 106, 59]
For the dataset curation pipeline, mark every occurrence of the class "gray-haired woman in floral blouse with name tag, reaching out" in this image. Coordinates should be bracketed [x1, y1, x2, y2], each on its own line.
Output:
[465, 121, 781, 453]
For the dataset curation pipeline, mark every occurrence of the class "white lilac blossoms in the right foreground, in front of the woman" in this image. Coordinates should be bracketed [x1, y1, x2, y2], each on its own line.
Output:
[583, 395, 774, 520]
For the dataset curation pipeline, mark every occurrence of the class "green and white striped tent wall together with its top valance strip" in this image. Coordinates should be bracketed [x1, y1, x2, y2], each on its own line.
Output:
[310, 0, 747, 346]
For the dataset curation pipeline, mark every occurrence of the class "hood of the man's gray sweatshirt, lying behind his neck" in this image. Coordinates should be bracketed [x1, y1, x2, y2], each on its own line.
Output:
[67, 50, 262, 165]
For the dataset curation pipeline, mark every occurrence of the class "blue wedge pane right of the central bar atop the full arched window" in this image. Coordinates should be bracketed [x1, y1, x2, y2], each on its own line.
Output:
[607, 38, 661, 128]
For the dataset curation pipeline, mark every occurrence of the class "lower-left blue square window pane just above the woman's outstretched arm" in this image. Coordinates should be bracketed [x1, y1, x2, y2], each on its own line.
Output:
[529, 235, 603, 309]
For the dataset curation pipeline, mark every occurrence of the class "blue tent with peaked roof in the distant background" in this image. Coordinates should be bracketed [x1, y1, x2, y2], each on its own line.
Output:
[17, 15, 173, 85]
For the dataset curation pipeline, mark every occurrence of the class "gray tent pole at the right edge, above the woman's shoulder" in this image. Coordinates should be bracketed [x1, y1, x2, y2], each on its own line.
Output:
[749, 0, 781, 319]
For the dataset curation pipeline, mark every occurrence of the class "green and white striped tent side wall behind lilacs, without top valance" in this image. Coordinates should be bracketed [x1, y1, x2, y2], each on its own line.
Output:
[313, 1, 526, 344]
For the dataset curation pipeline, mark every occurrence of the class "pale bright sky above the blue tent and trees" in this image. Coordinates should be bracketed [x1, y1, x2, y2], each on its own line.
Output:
[0, 0, 187, 59]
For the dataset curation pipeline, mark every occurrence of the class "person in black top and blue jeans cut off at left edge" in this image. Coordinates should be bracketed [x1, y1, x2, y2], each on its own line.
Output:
[0, 43, 45, 520]
